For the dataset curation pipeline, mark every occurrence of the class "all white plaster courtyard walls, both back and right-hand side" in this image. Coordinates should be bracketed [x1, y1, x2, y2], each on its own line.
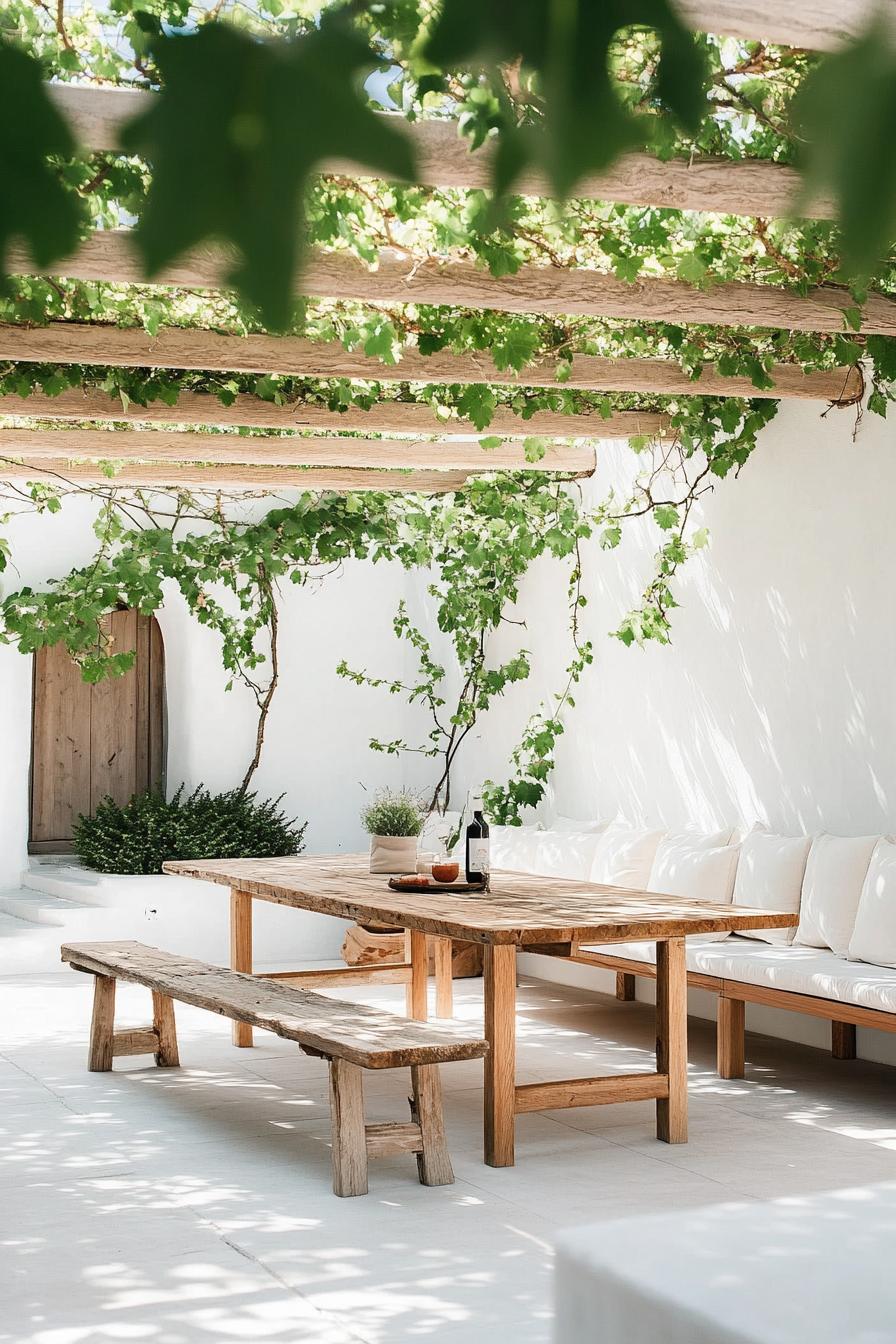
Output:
[0, 402, 896, 1058]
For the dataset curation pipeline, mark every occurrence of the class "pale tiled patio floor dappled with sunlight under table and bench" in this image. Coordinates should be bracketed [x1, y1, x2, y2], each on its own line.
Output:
[0, 973, 896, 1344]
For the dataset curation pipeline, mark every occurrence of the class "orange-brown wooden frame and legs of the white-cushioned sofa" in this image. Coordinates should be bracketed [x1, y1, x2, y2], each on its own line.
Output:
[570, 948, 896, 1078]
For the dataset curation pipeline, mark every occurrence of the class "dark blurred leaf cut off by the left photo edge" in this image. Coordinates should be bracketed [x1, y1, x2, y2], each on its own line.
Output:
[0, 40, 83, 276]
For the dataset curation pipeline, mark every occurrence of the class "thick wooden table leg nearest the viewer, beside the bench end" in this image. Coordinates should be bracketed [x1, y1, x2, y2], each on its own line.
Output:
[484, 945, 516, 1167]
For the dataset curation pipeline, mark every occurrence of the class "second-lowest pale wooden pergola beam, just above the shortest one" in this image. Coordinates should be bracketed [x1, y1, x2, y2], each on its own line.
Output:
[0, 429, 595, 476]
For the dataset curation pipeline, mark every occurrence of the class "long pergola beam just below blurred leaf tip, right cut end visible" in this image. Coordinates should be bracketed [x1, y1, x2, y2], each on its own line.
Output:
[0, 323, 864, 403]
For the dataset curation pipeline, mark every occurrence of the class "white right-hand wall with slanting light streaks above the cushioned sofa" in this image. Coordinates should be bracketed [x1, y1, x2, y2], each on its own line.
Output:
[470, 407, 896, 833]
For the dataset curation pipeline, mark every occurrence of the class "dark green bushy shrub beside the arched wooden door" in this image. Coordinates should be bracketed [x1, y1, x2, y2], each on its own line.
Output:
[74, 784, 305, 872]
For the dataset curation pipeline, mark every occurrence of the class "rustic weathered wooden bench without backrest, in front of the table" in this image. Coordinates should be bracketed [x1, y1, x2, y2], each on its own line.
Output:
[62, 942, 488, 1195]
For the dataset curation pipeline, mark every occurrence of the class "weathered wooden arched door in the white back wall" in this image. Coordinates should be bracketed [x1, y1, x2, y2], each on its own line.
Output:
[30, 610, 165, 853]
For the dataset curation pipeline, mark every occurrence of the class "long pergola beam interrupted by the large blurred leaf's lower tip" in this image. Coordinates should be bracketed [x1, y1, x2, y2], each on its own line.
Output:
[15, 230, 896, 336]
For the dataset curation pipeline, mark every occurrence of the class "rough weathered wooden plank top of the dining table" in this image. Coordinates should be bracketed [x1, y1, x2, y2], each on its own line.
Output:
[163, 853, 799, 948]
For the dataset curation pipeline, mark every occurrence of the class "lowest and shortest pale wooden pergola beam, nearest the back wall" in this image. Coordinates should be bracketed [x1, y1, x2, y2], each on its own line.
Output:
[0, 457, 469, 495]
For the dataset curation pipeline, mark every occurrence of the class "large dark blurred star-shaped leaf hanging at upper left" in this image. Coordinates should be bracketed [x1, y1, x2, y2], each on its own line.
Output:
[121, 13, 414, 328]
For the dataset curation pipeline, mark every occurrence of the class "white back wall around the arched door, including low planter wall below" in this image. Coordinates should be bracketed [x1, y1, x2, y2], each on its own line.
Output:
[0, 501, 427, 965]
